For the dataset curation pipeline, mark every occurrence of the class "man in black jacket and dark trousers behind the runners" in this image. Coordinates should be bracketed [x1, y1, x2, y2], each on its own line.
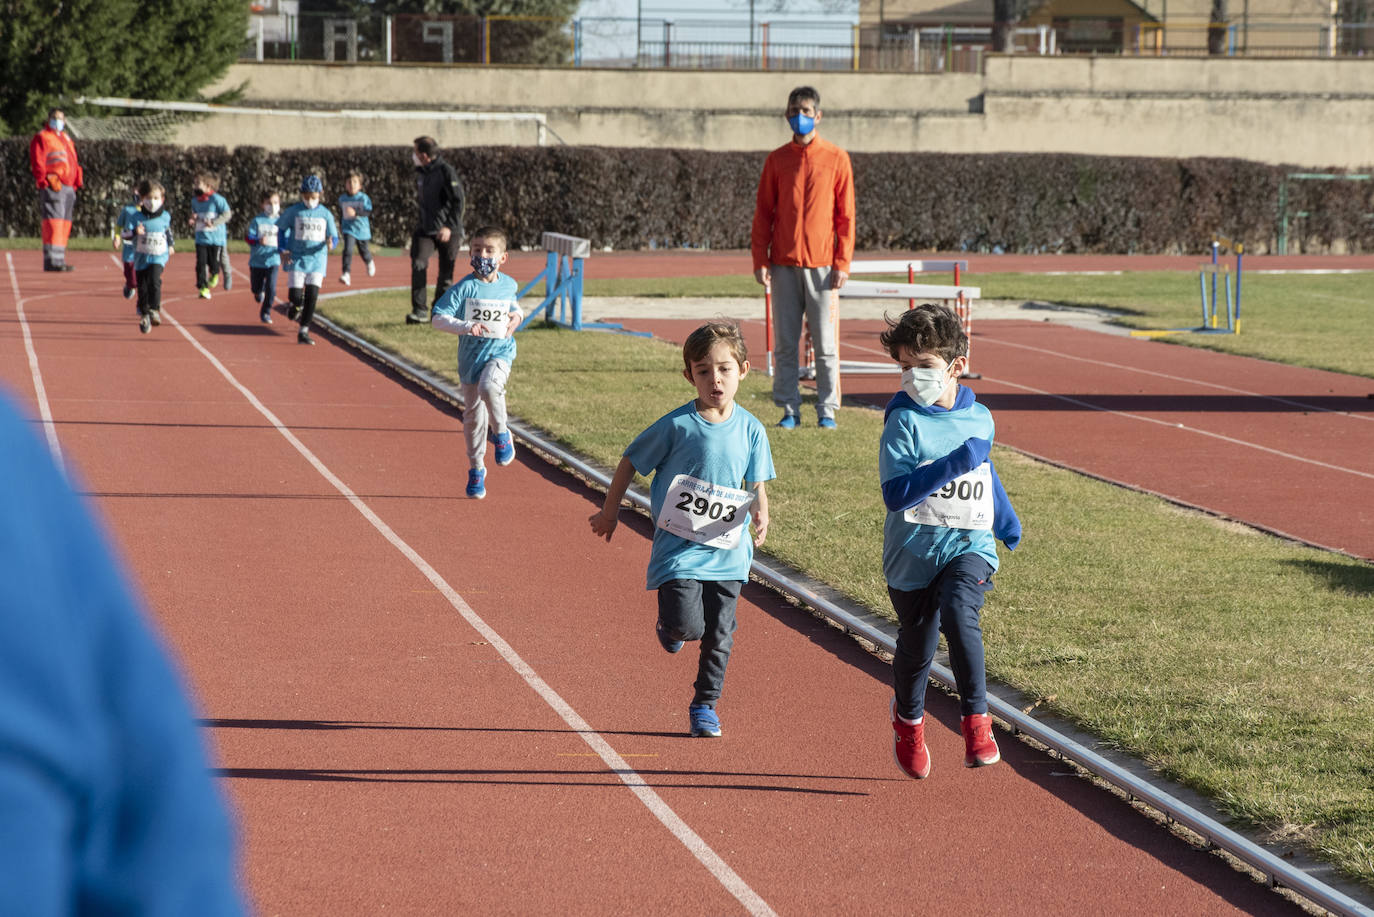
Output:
[405, 137, 464, 324]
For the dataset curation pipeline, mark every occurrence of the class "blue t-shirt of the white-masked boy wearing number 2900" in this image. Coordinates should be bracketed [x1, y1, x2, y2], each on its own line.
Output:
[878, 386, 998, 591]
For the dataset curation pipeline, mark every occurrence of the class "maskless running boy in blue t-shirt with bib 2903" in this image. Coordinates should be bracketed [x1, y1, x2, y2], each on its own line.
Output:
[591, 322, 774, 736]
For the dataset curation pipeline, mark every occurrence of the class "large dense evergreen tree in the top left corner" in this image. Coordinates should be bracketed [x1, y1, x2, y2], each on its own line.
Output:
[0, 0, 249, 135]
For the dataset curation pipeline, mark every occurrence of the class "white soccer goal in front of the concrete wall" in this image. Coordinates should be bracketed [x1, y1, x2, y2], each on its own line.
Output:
[67, 96, 562, 150]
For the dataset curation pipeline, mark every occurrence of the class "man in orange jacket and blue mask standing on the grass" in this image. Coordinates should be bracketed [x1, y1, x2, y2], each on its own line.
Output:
[749, 87, 855, 429]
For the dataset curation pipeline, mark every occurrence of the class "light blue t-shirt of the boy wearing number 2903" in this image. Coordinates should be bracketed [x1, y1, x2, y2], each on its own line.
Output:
[625, 401, 774, 588]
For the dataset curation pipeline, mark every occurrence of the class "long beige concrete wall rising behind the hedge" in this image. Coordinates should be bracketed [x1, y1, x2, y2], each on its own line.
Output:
[199, 55, 1374, 168]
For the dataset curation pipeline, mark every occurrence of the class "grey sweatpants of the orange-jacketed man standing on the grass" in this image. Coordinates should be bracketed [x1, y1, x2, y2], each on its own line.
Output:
[768, 264, 840, 417]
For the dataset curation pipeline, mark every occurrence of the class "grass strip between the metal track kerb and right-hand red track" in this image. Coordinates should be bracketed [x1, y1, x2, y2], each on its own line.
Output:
[322, 294, 1374, 888]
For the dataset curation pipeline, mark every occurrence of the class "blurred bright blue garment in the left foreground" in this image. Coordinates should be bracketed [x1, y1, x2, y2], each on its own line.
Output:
[0, 395, 245, 917]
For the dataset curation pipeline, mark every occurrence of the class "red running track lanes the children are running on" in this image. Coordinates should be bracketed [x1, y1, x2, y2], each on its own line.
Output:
[0, 247, 1330, 914]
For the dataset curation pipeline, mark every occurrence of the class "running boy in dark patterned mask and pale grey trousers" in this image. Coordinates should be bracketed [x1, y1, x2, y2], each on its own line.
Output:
[433, 225, 523, 500]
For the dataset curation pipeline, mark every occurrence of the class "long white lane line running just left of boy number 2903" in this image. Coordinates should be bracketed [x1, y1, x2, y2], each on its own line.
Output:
[162, 309, 775, 916]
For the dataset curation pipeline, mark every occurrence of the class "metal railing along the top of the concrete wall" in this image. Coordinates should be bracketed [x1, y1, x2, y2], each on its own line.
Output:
[240, 7, 1374, 73]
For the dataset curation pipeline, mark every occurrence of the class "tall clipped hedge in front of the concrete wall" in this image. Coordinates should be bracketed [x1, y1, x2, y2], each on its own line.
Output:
[0, 139, 1374, 254]
